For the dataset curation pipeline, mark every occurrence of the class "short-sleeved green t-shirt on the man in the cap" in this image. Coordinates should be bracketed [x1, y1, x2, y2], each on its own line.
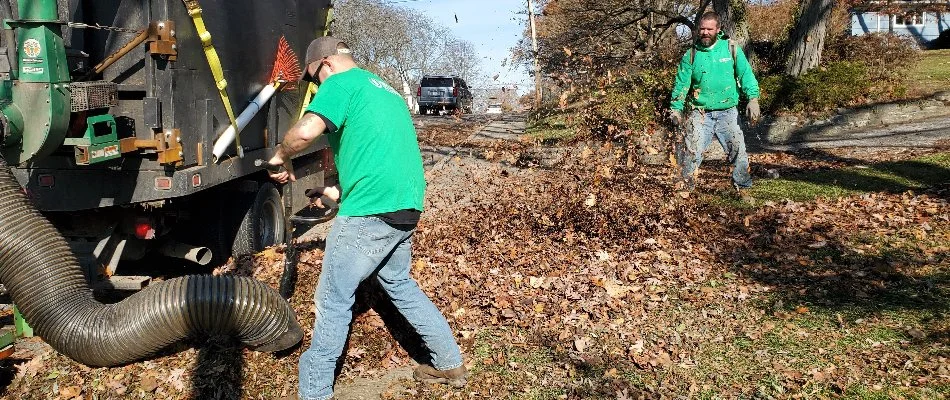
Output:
[307, 68, 426, 217]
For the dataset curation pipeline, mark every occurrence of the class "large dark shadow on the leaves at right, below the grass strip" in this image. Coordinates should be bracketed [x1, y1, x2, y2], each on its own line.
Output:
[727, 212, 950, 343]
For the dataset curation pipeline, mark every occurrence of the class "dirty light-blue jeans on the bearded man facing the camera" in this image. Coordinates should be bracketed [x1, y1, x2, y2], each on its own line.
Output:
[677, 107, 752, 189]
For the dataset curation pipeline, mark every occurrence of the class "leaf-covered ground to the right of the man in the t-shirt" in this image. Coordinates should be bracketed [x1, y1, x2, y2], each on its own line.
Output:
[407, 148, 950, 398]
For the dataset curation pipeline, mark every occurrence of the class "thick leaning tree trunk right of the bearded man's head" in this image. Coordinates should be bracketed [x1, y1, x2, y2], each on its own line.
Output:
[785, 0, 835, 76]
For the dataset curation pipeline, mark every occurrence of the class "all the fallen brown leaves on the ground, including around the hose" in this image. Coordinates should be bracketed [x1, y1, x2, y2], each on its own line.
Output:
[4, 124, 950, 399]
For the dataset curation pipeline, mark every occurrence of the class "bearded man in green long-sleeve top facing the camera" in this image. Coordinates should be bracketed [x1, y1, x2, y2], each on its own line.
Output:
[670, 11, 760, 193]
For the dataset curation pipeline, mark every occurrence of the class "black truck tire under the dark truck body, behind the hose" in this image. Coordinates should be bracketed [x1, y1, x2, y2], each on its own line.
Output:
[231, 182, 285, 257]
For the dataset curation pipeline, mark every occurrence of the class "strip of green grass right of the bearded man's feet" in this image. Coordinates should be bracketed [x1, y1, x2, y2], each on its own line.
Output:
[748, 153, 950, 204]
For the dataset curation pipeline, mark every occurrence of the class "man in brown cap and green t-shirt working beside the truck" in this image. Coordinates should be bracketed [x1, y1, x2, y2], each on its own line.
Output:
[270, 37, 467, 400]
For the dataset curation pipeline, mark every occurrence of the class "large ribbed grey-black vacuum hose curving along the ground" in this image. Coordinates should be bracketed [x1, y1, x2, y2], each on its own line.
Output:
[0, 160, 303, 367]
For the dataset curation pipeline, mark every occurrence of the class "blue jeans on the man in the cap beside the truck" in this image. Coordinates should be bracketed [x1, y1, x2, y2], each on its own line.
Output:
[299, 217, 462, 400]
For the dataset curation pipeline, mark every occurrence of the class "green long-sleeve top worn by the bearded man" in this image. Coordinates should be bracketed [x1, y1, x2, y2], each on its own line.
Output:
[670, 34, 759, 111]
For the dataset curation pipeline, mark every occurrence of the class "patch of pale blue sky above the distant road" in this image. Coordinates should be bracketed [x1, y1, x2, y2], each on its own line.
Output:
[390, 0, 537, 93]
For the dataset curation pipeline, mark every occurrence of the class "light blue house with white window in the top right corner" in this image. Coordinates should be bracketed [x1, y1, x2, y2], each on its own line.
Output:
[851, 0, 950, 46]
